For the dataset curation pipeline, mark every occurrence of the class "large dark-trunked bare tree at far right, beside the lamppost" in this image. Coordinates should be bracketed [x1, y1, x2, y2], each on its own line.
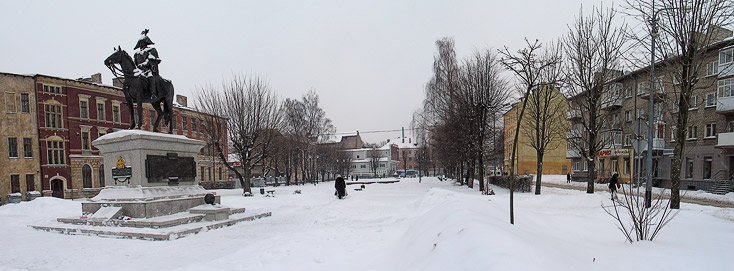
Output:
[627, 0, 734, 209]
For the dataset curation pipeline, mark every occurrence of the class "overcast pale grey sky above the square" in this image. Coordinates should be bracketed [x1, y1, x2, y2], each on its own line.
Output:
[0, 0, 610, 143]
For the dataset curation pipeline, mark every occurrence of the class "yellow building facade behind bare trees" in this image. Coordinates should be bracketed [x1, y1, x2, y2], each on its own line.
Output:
[504, 89, 571, 175]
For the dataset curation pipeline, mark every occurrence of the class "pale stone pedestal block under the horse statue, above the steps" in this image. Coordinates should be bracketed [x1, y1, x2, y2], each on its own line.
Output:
[92, 130, 206, 187]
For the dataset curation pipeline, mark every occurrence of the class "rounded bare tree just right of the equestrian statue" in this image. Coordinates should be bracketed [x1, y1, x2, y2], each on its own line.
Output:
[196, 75, 282, 194]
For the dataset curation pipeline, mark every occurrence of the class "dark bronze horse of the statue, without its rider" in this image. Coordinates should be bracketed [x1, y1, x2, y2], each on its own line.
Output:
[104, 46, 175, 134]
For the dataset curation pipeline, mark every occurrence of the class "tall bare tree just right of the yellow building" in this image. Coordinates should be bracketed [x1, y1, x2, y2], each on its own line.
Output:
[563, 5, 625, 193]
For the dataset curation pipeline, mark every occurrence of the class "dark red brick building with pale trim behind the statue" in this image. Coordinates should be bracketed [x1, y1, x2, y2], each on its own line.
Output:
[0, 74, 228, 198]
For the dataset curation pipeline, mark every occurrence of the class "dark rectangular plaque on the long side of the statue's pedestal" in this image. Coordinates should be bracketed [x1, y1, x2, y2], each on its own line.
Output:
[145, 154, 196, 183]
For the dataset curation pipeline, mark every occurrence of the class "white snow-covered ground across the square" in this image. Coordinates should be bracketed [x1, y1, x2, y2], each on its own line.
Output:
[0, 178, 734, 271]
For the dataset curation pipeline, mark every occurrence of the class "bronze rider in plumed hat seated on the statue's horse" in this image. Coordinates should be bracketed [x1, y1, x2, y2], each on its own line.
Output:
[133, 29, 161, 100]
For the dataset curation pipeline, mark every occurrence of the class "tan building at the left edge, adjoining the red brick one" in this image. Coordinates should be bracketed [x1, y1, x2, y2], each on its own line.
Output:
[0, 73, 41, 203]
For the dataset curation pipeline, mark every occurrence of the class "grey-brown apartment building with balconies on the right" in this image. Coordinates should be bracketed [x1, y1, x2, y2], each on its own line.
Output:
[567, 27, 734, 189]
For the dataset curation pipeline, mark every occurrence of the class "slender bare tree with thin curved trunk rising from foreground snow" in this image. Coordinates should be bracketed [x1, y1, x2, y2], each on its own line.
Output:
[500, 39, 560, 224]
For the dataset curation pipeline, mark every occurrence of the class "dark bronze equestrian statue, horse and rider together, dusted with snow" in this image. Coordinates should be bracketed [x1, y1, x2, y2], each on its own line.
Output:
[104, 29, 176, 134]
